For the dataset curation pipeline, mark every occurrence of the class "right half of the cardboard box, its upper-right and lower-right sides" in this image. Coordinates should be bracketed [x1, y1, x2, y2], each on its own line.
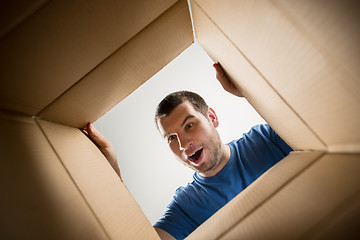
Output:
[188, 0, 360, 239]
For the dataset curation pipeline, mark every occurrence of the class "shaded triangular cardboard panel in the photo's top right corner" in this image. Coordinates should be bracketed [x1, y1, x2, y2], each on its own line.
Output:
[273, 0, 360, 78]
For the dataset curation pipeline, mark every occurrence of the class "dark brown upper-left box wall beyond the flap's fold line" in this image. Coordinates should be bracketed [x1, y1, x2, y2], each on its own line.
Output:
[0, 0, 175, 115]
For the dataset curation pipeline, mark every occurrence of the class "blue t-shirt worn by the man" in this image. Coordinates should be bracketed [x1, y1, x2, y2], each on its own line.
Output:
[154, 124, 292, 239]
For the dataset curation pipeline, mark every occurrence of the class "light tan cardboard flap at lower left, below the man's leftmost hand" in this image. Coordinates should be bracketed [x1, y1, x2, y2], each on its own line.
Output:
[38, 120, 158, 239]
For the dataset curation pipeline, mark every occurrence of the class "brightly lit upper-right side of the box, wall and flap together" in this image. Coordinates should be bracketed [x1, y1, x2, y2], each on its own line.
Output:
[192, 0, 360, 152]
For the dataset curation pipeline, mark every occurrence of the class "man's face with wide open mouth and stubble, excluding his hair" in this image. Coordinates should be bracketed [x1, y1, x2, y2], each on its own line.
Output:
[158, 101, 222, 176]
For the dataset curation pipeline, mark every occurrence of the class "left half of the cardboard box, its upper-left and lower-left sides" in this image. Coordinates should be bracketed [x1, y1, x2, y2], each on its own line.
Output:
[0, 0, 193, 239]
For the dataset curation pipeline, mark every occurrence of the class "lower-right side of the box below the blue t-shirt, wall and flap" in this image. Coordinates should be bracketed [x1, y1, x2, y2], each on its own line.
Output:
[188, 152, 360, 239]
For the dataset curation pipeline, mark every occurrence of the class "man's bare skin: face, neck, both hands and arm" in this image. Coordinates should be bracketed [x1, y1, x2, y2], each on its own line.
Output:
[86, 63, 243, 240]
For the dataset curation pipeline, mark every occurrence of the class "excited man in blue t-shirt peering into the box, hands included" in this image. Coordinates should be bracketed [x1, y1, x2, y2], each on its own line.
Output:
[88, 64, 291, 239]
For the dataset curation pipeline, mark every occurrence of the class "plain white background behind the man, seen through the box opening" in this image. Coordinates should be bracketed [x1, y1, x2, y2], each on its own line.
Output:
[94, 43, 265, 224]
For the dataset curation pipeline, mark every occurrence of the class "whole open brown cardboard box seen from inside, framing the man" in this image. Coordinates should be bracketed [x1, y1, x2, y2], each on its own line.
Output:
[0, 0, 360, 239]
